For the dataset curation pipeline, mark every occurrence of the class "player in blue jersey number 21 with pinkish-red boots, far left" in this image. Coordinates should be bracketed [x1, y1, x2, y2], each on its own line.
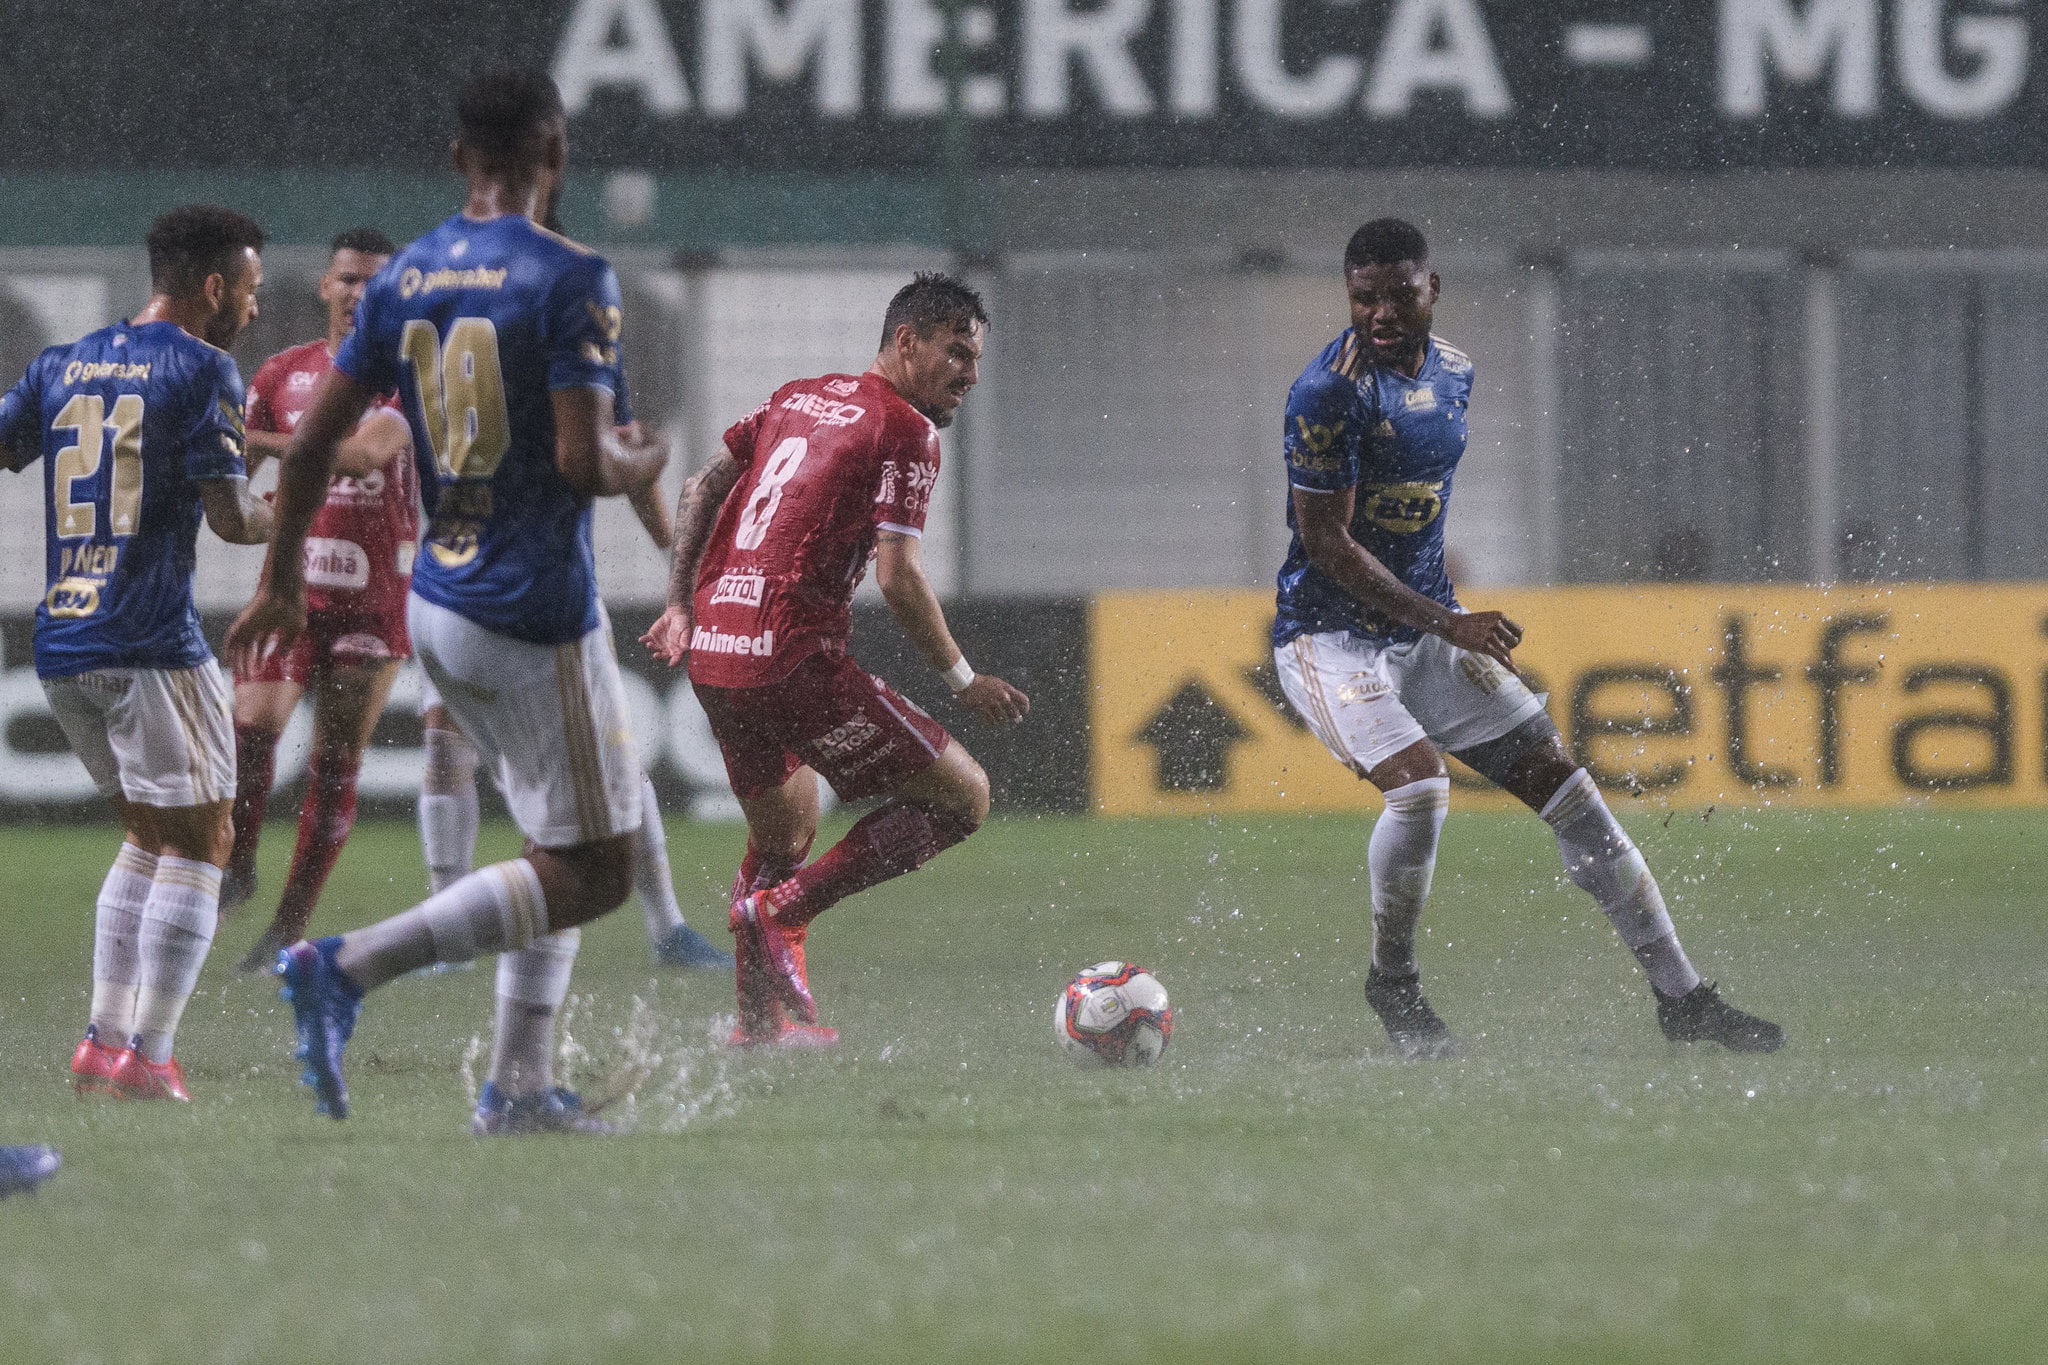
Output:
[0, 205, 270, 1099]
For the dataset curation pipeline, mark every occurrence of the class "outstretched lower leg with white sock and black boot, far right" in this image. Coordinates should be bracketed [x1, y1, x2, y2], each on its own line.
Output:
[1540, 767, 1784, 1052]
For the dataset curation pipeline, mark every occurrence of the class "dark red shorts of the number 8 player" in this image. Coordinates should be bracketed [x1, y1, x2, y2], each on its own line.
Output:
[696, 651, 952, 800]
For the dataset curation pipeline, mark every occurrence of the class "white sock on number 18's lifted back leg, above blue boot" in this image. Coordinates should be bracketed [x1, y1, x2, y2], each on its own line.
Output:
[334, 857, 547, 990]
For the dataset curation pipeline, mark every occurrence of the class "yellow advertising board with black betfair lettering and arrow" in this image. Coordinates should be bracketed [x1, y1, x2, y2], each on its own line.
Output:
[1090, 583, 2048, 814]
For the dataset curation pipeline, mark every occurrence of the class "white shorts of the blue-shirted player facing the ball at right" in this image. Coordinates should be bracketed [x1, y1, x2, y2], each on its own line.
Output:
[1274, 630, 1542, 778]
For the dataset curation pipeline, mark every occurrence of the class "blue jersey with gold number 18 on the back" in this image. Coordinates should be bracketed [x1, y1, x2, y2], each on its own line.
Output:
[334, 215, 621, 645]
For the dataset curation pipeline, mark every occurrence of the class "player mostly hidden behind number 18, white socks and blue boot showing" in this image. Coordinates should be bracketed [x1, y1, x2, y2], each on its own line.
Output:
[418, 205, 733, 972]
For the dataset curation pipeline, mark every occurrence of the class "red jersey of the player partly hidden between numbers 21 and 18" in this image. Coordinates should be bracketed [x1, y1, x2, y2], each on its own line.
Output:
[248, 342, 420, 620]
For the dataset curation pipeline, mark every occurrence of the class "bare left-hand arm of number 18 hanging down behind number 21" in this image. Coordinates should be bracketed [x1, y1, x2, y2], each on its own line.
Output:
[227, 368, 377, 663]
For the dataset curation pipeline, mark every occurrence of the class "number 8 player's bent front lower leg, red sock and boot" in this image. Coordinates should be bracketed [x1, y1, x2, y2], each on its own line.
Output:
[731, 741, 989, 1023]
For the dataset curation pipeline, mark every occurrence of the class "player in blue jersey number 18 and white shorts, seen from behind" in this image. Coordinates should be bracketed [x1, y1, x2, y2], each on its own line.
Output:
[227, 68, 668, 1134]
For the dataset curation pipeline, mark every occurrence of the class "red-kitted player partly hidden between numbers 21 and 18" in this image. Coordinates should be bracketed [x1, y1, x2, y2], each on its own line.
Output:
[221, 227, 420, 972]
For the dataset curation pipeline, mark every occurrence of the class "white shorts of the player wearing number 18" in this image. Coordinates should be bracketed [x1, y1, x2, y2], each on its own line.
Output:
[406, 593, 641, 849]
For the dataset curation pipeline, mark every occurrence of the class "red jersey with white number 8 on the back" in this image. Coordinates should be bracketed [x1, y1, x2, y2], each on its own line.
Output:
[690, 375, 938, 688]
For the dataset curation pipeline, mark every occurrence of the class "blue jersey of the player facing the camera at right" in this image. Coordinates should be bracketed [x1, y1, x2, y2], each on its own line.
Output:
[1274, 327, 1473, 645]
